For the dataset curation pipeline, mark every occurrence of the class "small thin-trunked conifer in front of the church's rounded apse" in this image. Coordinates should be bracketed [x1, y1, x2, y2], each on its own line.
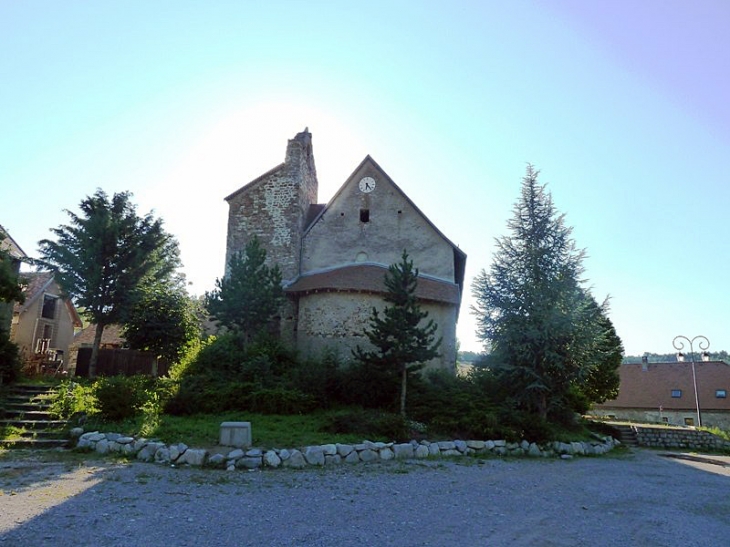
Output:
[353, 250, 441, 417]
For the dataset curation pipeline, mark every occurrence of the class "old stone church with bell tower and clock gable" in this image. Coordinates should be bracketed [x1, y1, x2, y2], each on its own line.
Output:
[225, 129, 466, 370]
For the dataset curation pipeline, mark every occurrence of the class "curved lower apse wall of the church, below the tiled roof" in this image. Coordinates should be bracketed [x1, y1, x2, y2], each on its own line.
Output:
[297, 292, 456, 371]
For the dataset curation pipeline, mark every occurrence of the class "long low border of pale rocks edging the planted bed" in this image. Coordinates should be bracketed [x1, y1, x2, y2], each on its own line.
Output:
[72, 429, 619, 471]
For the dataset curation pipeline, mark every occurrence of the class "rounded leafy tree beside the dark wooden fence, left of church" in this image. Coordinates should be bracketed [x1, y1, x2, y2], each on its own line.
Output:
[123, 278, 200, 362]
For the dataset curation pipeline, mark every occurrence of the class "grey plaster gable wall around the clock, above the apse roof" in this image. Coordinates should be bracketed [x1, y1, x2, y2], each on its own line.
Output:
[302, 164, 454, 283]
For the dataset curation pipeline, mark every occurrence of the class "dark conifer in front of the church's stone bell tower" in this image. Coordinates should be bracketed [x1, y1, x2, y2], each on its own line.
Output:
[206, 237, 284, 341]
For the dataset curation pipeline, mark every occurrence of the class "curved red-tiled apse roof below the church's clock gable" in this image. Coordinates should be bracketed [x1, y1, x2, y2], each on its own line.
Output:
[285, 264, 460, 305]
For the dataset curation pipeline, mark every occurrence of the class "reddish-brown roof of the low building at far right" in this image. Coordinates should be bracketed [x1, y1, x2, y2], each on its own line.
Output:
[596, 361, 730, 411]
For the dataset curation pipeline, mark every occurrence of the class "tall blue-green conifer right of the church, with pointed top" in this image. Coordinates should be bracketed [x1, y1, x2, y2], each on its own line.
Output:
[472, 165, 616, 419]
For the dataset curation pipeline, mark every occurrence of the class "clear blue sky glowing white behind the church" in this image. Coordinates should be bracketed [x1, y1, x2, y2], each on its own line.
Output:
[0, 0, 730, 354]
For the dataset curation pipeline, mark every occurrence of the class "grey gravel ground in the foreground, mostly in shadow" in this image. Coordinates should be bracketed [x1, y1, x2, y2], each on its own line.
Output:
[0, 450, 730, 547]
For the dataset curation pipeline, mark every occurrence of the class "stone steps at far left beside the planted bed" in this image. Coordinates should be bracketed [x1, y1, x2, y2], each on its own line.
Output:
[0, 384, 68, 449]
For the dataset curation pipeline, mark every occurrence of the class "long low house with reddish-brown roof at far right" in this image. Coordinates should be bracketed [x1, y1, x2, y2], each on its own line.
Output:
[590, 361, 730, 431]
